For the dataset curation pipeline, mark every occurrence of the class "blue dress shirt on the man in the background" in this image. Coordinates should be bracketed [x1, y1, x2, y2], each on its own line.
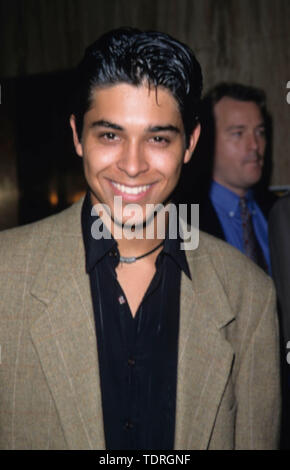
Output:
[209, 181, 271, 273]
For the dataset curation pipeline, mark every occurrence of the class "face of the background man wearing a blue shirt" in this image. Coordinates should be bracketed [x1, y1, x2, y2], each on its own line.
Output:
[213, 97, 266, 196]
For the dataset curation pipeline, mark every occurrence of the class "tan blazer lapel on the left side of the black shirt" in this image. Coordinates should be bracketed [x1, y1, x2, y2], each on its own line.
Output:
[31, 204, 105, 449]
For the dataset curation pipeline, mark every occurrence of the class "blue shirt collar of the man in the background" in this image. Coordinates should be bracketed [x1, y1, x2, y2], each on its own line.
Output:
[209, 181, 254, 217]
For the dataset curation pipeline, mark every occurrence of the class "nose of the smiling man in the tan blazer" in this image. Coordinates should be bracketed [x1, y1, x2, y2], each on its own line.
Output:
[117, 141, 149, 178]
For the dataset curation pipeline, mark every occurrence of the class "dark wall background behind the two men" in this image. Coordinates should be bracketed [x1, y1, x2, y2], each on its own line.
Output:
[0, 0, 290, 229]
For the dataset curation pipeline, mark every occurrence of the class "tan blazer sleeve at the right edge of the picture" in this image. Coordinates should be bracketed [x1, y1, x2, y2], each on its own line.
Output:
[235, 282, 281, 450]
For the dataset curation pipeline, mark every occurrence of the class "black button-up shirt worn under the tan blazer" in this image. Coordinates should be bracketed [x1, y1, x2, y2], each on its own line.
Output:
[82, 193, 190, 450]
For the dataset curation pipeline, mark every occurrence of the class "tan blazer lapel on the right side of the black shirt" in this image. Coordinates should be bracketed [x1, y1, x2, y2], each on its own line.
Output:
[175, 246, 233, 449]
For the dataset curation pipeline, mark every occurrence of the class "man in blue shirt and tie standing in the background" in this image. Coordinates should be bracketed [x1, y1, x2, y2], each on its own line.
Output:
[200, 83, 273, 273]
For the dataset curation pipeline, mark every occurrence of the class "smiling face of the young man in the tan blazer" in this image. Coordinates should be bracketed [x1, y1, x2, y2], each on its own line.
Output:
[71, 84, 199, 228]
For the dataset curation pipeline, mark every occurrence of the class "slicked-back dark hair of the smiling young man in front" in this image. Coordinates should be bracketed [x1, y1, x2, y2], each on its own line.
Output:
[73, 28, 202, 145]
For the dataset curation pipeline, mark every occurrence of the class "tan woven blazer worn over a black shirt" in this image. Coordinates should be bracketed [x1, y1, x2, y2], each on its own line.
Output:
[0, 201, 280, 449]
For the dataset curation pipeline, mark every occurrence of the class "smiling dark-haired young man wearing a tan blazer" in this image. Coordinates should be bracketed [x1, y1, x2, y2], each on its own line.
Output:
[0, 29, 280, 450]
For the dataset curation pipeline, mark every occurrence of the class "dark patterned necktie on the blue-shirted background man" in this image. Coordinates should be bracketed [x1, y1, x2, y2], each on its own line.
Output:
[240, 197, 268, 273]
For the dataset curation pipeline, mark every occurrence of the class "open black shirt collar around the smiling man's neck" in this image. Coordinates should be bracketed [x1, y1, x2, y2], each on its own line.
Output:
[81, 191, 191, 278]
